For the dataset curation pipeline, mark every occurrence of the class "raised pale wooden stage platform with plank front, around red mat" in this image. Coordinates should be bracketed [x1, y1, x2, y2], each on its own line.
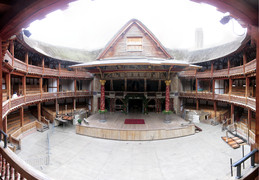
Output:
[76, 113, 195, 141]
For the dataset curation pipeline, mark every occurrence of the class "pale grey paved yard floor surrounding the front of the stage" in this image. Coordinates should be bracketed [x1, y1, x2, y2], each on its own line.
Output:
[17, 121, 252, 180]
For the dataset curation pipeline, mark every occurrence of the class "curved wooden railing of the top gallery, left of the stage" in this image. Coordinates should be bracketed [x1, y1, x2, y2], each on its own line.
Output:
[4, 51, 92, 78]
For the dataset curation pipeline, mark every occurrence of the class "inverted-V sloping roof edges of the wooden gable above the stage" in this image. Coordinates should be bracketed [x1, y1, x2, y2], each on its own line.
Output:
[97, 19, 173, 60]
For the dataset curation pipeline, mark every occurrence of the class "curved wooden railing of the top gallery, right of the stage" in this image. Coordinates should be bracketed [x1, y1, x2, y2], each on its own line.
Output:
[179, 59, 256, 78]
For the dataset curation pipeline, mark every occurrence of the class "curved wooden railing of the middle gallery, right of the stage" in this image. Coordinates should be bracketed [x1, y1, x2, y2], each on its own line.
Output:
[179, 92, 256, 110]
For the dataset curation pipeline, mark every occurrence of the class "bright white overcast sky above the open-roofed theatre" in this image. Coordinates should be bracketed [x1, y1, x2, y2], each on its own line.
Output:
[27, 0, 246, 50]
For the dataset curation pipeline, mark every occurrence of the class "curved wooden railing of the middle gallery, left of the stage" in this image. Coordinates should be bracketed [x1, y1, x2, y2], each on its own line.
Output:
[2, 91, 92, 118]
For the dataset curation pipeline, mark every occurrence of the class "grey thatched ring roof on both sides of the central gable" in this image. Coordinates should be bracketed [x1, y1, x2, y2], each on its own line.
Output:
[19, 29, 249, 64]
